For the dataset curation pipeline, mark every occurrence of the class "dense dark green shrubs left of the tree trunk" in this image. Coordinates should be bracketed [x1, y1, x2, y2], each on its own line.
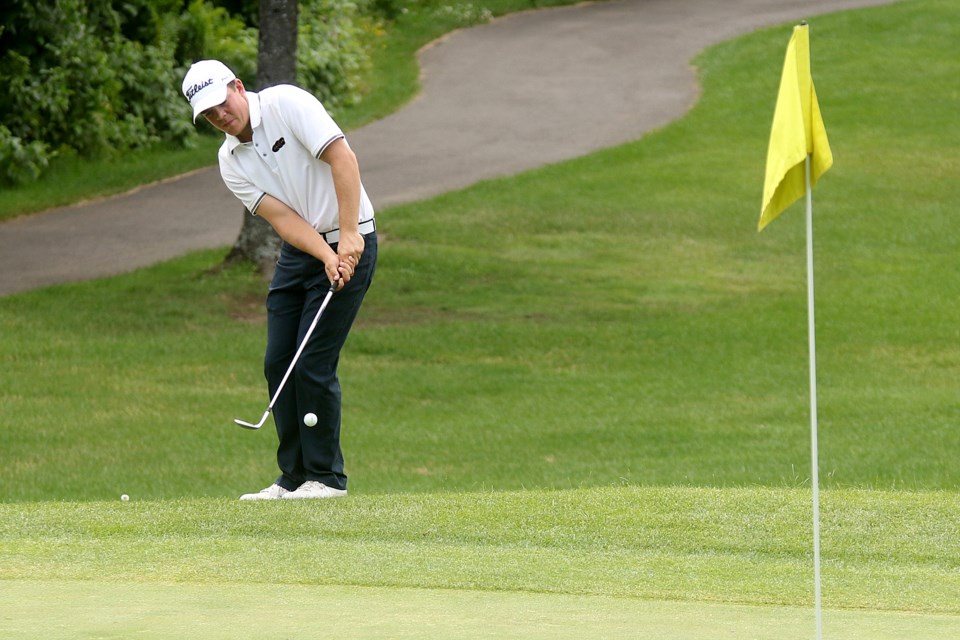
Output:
[0, 0, 256, 184]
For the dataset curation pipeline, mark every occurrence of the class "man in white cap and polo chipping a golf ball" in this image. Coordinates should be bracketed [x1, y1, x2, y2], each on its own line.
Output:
[183, 60, 377, 500]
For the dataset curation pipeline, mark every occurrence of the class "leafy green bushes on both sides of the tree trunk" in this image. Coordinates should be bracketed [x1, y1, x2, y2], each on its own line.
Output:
[0, 0, 383, 186]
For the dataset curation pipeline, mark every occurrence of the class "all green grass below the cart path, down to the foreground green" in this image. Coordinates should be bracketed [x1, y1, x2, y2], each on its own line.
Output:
[0, 0, 960, 640]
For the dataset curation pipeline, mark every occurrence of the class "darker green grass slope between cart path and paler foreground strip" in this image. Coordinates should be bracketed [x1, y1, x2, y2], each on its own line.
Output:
[0, 2, 960, 500]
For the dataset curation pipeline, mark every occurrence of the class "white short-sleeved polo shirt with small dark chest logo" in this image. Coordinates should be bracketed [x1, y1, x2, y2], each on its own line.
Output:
[219, 85, 373, 233]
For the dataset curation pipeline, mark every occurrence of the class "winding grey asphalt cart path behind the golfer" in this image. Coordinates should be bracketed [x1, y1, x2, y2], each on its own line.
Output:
[0, 0, 890, 295]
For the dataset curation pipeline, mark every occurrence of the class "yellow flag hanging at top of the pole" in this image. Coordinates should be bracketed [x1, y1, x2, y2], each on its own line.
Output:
[758, 24, 833, 230]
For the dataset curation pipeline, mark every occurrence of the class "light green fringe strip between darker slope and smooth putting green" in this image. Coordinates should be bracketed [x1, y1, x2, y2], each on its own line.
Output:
[0, 487, 960, 612]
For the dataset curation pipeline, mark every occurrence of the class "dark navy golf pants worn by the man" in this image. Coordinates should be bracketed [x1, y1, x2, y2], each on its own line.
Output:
[264, 232, 377, 491]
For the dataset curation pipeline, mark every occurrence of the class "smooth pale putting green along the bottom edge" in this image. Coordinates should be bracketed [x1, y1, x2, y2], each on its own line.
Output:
[0, 580, 960, 640]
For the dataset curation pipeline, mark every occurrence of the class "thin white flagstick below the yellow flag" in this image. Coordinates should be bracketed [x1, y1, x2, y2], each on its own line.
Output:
[806, 154, 823, 640]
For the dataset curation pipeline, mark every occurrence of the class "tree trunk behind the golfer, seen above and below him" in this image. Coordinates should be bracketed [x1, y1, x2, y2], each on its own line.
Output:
[227, 0, 299, 277]
